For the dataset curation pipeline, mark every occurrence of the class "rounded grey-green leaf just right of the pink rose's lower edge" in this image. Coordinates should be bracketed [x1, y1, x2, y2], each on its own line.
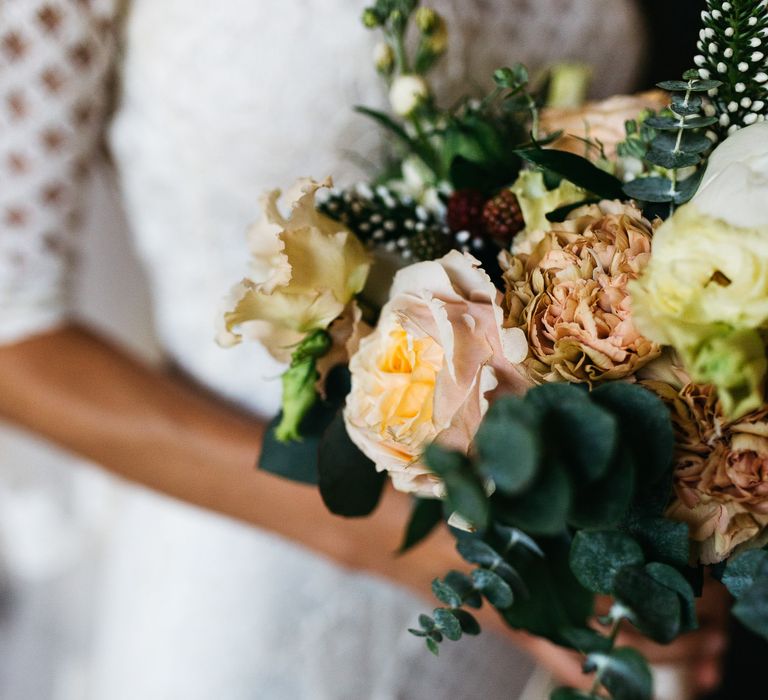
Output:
[475, 397, 542, 495]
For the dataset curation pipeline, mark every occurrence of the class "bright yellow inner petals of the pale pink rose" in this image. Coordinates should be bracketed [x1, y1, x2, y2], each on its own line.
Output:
[377, 328, 443, 433]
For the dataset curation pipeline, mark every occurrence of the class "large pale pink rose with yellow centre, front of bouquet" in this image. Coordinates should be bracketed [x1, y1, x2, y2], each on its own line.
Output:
[344, 251, 531, 497]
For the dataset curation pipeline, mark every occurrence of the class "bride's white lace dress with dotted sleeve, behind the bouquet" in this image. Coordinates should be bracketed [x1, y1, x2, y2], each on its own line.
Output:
[0, 0, 643, 700]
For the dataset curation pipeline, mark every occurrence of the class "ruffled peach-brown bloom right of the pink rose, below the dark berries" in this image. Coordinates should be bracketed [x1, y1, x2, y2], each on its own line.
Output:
[503, 201, 660, 384]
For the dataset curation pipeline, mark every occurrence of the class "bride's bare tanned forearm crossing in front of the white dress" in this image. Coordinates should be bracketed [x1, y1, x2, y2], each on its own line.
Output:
[0, 328, 459, 594]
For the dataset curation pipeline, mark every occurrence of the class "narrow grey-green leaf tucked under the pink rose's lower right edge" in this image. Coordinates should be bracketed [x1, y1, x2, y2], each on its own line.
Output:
[424, 444, 489, 529]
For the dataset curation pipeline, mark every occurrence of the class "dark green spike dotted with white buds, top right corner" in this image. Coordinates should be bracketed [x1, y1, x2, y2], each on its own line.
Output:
[694, 0, 768, 138]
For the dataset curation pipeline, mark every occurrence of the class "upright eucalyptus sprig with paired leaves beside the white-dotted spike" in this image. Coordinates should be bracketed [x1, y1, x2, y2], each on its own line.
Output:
[624, 71, 721, 215]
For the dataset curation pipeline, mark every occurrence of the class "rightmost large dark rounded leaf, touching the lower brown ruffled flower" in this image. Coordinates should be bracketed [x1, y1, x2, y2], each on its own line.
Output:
[592, 382, 675, 484]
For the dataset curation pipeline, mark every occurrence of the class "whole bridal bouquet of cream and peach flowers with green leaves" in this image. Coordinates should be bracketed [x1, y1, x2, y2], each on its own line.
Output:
[221, 0, 768, 700]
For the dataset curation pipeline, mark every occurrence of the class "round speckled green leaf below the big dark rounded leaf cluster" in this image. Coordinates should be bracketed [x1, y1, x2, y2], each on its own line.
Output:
[571, 530, 645, 593]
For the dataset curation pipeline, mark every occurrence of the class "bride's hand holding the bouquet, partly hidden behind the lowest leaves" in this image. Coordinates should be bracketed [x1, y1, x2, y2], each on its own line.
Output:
[508, 580, 730, 696]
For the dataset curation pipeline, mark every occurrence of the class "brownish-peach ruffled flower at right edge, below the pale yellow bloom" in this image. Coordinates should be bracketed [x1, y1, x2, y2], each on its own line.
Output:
[647, 382, 768, 564]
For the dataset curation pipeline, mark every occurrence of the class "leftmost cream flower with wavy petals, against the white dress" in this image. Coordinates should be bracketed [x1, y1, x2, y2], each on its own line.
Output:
[219, 179, 370, 361]
